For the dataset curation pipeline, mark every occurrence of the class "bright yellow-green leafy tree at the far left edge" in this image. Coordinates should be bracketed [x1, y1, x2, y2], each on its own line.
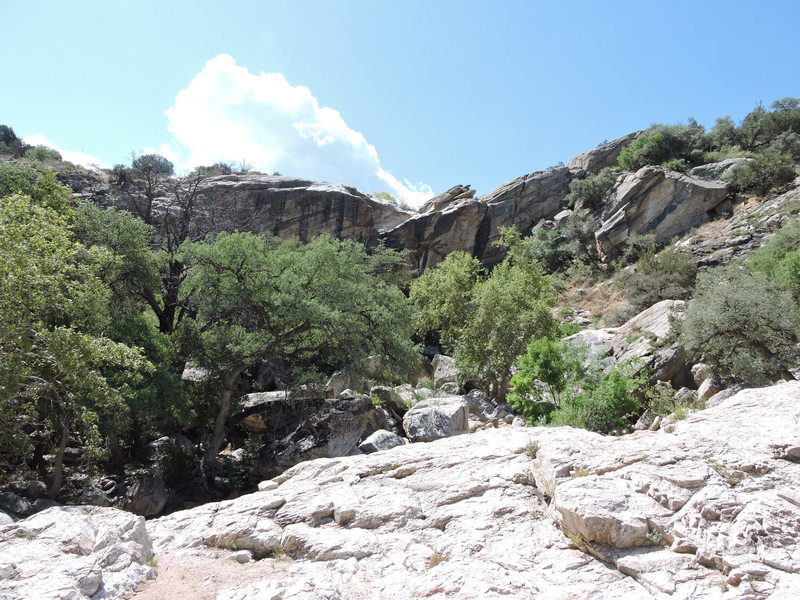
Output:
[0, 195, 150, 497]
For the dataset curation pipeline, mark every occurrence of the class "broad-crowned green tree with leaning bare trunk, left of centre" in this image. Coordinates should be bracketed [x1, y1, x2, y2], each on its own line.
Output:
[183, 233, 418, 464]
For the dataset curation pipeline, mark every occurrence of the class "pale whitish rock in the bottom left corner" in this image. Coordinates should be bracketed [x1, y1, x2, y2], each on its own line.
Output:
[0, 506, 153, 600]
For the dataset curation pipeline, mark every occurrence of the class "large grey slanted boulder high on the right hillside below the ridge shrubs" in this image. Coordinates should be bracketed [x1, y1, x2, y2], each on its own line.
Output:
[595, 167, 728, 260]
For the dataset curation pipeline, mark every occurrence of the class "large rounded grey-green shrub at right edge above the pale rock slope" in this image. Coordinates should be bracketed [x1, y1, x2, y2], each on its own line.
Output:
[681, 265, 800, 385]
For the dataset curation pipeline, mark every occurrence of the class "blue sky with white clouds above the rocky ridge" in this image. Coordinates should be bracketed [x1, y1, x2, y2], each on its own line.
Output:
[0, 0, 800, 202]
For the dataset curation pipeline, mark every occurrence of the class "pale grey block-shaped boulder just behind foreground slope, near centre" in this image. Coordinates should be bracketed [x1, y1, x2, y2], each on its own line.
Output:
[403, 396, 469, 442]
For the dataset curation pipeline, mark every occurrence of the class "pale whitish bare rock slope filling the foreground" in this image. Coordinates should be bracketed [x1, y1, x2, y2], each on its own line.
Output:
[0, 382, 800, 600]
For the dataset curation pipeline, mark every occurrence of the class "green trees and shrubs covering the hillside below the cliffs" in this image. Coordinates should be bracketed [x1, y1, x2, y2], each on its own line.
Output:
[0, 98, 800, 510]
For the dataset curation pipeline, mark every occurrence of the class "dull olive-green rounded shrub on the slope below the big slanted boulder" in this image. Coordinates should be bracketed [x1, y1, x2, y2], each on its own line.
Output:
[619, 248, 697, 312]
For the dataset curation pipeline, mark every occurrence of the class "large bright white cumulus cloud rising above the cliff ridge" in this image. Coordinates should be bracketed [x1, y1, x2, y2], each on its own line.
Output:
[166, 54, 433, 206]
